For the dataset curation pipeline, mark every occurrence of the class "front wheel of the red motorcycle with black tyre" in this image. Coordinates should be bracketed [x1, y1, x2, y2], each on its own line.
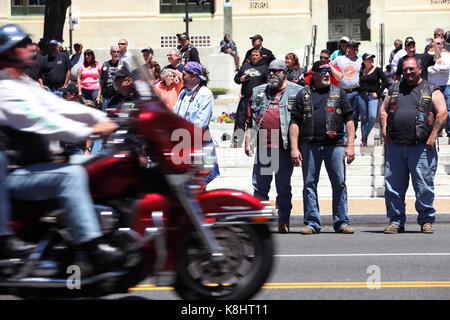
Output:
[174, 224, 273, 300]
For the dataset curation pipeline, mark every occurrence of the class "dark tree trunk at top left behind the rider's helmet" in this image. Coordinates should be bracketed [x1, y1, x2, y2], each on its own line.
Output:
[39, 0, 72, 54]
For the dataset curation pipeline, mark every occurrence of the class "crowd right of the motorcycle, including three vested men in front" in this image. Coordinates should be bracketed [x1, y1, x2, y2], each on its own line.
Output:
[229, 28, 450, 234]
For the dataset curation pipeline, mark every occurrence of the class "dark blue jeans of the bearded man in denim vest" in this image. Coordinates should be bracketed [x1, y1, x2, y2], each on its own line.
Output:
[252, 148, 294, 224]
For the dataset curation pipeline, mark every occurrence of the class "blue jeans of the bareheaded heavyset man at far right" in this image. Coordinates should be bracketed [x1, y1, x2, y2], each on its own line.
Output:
[384, 142, 438, 226]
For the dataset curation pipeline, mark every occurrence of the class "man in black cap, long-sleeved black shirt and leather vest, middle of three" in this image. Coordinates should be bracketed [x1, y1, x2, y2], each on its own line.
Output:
[289, 61, 355, 234]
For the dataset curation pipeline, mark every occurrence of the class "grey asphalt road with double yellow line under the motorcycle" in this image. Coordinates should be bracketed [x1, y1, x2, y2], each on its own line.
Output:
[0, 224, 450, 303]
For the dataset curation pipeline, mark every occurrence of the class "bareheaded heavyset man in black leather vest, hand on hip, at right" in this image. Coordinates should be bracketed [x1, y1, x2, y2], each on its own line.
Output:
[380, 57, 447, 234]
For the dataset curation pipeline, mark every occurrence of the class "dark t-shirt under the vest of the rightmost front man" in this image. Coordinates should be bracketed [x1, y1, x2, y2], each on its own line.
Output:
[388, 81, 438, 144]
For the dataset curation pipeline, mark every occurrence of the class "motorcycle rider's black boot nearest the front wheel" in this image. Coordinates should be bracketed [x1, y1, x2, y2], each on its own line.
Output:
[81, 239, 126, 272]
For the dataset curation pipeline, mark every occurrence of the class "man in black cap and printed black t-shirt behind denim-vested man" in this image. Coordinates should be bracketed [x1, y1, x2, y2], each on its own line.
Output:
[233, 49, 268, 148]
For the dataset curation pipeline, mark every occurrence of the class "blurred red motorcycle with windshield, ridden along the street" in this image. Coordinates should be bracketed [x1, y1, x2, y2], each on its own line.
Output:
[0, 65, 274, 299]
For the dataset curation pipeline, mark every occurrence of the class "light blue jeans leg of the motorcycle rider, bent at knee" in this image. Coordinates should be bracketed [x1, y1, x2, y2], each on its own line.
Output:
[7, 163, 102, 244]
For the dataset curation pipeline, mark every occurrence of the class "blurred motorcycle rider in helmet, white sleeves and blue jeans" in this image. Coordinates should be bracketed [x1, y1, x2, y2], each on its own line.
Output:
[0, 24, 123, 269]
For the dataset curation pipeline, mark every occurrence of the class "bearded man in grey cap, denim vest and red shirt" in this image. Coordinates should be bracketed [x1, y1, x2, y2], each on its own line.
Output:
[245, 60, 302, 233]
